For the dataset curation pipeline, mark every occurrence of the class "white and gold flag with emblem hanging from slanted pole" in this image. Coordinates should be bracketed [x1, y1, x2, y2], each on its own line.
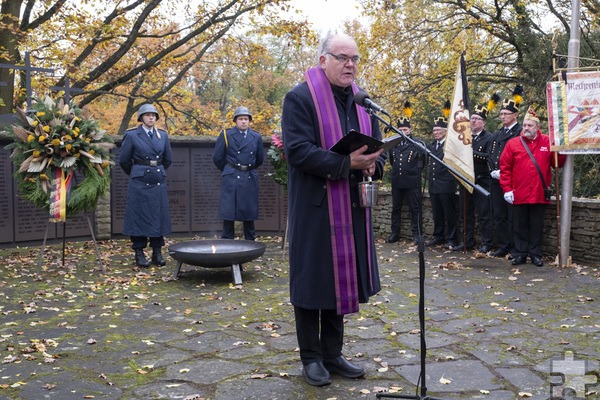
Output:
[444, 54, 475, 193]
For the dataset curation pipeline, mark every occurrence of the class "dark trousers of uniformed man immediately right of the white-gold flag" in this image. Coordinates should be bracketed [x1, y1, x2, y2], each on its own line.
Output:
[458, 179, 493, 247]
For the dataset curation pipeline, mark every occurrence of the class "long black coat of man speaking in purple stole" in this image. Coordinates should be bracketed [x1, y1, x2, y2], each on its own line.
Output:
[281, 82, 385, 309]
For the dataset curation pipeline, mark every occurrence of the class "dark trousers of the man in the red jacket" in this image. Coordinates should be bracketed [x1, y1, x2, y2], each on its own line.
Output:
[513, 204, 546, 257]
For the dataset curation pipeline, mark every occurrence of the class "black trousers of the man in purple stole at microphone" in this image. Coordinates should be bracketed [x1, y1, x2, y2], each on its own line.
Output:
[294, 307, 344, 365]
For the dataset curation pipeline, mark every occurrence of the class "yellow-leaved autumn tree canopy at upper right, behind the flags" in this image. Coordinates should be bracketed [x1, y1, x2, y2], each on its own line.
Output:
[362, 0, 600, 134]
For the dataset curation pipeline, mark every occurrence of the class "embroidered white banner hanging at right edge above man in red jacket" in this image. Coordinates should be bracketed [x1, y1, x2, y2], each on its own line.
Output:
[546, 72, 600, 153]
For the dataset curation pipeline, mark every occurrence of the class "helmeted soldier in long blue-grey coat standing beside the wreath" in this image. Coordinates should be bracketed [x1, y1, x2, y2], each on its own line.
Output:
[119, 104, 173, 268]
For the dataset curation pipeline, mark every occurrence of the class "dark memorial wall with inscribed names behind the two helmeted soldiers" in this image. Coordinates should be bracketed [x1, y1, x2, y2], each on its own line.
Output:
[0, 137, 286, 246]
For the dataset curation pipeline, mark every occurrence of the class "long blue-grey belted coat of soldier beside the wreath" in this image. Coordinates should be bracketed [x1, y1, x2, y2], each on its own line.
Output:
[119, 125, 173, 237]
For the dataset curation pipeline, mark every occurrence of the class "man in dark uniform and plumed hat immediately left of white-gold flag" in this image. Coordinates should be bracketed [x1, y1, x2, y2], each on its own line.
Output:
[426, 117, 458, 249]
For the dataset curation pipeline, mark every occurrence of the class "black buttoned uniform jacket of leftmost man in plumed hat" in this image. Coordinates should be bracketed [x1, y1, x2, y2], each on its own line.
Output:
[389, 136, 425, 189]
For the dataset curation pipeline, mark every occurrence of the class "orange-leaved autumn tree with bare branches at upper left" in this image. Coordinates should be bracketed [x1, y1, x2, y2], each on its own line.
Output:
[0, 0, 308, 133]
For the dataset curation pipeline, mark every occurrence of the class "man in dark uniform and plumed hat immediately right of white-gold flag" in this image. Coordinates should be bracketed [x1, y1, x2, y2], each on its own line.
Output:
[452, 103, 493, 253]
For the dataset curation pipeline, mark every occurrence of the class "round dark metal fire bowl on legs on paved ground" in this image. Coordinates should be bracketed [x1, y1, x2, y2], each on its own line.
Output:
[169, 239, 266, 284]
